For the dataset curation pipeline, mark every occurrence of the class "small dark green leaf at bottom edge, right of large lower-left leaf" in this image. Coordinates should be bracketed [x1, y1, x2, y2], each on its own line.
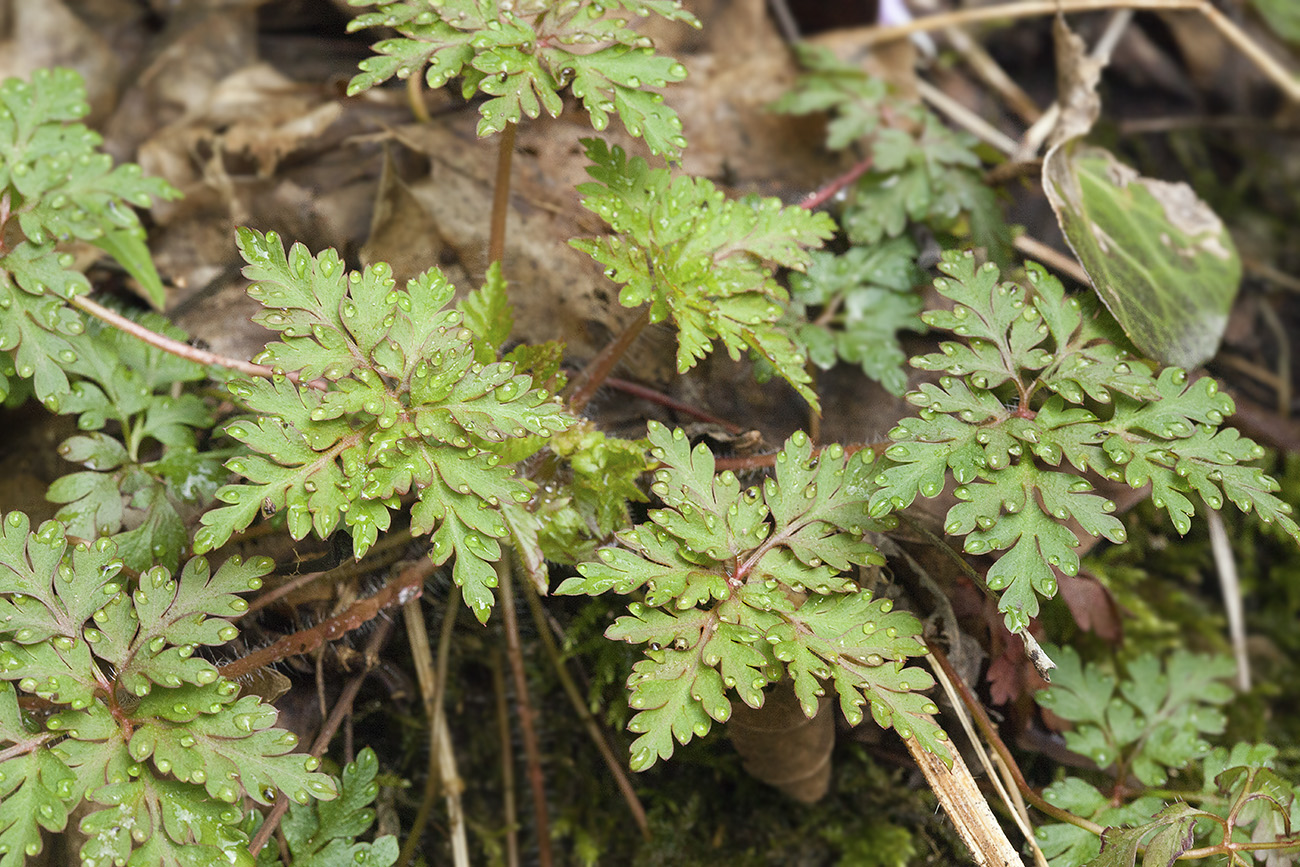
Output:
[257, 747, 398, 867]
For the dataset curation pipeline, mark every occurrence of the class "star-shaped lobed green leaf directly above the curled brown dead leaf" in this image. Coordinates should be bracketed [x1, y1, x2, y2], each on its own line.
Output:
[556, 422, 946, 770]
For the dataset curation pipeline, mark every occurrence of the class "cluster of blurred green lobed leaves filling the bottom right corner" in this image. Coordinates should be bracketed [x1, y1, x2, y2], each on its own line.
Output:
[1036, 647, 1300, 867]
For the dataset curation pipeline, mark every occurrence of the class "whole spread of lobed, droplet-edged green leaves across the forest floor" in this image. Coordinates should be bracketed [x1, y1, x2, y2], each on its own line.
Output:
[0, 0, 1300, 867]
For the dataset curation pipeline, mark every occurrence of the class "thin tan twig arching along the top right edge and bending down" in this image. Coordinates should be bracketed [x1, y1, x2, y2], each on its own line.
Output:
[859, 0, 1300, 101]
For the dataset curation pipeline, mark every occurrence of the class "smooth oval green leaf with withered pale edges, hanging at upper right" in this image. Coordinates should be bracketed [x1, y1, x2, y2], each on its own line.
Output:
[1043, 142, 1242, 369]
